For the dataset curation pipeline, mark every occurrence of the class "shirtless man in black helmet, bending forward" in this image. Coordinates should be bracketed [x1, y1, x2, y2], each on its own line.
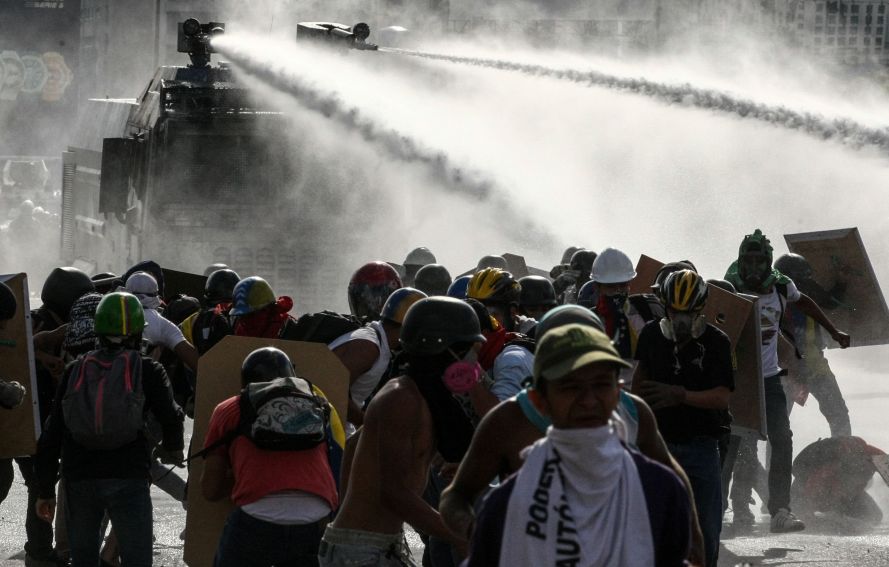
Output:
[319, 297, 484, 566]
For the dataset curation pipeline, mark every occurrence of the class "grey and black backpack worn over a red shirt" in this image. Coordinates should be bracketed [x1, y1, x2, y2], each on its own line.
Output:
[198, 377, 330, 460]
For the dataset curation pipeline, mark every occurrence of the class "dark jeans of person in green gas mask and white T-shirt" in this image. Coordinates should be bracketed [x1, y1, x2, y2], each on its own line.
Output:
[765, 376, 793, 515]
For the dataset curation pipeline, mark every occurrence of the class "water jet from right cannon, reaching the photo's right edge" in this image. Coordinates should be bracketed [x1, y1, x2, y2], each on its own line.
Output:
[380, 47, 889, 153]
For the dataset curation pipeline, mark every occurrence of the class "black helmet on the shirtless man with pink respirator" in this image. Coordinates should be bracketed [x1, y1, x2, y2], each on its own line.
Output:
[401, 297, 485, 356]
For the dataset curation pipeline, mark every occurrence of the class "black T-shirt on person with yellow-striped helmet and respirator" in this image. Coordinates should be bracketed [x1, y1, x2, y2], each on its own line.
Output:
[636, 321, 735, 443]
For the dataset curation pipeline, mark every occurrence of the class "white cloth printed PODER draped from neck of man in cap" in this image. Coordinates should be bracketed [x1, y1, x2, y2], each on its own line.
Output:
[500, 425, 654, 567]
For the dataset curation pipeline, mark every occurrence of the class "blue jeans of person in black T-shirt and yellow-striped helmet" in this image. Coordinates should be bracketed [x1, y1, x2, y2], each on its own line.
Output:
[667, 436, 722, 567]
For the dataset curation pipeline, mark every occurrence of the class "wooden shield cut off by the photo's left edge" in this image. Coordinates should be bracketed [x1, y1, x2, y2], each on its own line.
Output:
[0, 274, 40, 459]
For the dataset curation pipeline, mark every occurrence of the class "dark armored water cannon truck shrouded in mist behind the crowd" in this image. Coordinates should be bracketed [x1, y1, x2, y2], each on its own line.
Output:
[61, 20, 351, 310]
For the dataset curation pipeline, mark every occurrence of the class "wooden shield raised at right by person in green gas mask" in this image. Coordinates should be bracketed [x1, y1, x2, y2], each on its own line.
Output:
[784, 228, 889, 348]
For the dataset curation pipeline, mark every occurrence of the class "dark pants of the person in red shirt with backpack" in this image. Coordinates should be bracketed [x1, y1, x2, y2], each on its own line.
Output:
[213, 508, 327, 567]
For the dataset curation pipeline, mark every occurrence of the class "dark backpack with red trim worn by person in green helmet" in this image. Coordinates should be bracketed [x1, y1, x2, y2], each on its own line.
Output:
[62, 349, 145, 451]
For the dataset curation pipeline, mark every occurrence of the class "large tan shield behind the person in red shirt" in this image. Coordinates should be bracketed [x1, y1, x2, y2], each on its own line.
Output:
[184, 336, 349, 567]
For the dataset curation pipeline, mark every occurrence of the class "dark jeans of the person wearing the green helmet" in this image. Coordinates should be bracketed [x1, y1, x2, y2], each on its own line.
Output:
[65, 478, 153, 567]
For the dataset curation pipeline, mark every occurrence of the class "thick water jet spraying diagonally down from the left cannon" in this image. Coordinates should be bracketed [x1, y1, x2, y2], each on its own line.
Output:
[211, 41, 556, 247]
